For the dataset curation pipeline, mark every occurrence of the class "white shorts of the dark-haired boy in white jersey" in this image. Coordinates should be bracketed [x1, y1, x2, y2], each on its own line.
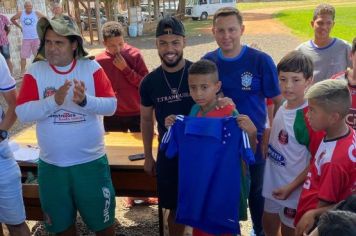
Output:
[264, 198, 297, 229]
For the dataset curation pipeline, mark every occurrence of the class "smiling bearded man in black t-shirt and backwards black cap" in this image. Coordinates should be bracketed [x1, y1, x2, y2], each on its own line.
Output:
[140, 16, 194, 235]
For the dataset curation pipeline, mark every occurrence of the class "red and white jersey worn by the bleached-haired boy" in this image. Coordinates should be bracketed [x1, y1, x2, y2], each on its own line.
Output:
[294, 128, 356, 225]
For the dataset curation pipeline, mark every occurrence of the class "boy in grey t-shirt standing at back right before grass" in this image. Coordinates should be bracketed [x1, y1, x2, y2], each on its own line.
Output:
[297, 3, 351, 83]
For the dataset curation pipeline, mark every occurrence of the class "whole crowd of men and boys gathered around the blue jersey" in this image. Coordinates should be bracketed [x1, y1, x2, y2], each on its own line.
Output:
[0, 1, 356, 236]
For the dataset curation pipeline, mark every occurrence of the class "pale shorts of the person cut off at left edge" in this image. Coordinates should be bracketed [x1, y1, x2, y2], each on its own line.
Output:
[0, 140, 26, 225]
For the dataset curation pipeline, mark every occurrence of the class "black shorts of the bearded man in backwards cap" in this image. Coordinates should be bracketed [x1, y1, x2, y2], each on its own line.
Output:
[157, 148, 178, 210]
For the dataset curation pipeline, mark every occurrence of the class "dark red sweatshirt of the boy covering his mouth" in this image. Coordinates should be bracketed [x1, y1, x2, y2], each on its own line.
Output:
[96, 43, 148, 116]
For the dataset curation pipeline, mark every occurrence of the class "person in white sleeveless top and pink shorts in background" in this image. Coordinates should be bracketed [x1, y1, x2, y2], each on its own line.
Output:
[11, 0, 45, 76]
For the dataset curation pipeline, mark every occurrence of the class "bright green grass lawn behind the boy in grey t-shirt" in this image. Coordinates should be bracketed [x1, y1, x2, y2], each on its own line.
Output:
[275, 3, 356, 42]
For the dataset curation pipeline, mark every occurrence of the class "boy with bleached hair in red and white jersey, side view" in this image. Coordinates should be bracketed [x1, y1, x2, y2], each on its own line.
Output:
[294, 80, 356, 236]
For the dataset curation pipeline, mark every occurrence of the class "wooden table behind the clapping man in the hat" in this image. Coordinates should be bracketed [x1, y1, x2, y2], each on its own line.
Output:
[13, 127, 162, 231]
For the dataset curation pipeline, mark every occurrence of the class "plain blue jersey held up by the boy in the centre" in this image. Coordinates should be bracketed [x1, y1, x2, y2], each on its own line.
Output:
[161, 116, 254, 234]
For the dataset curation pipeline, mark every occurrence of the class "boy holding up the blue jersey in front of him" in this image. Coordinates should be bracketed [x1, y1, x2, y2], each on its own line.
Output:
[165, 59, 257, 236]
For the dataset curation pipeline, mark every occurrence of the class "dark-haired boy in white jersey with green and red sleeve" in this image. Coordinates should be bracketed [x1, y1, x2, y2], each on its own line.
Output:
[262, 51, 322, 236]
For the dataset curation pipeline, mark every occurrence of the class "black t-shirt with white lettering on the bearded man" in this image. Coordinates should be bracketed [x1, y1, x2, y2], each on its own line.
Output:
[140, 60, 194, 140]
